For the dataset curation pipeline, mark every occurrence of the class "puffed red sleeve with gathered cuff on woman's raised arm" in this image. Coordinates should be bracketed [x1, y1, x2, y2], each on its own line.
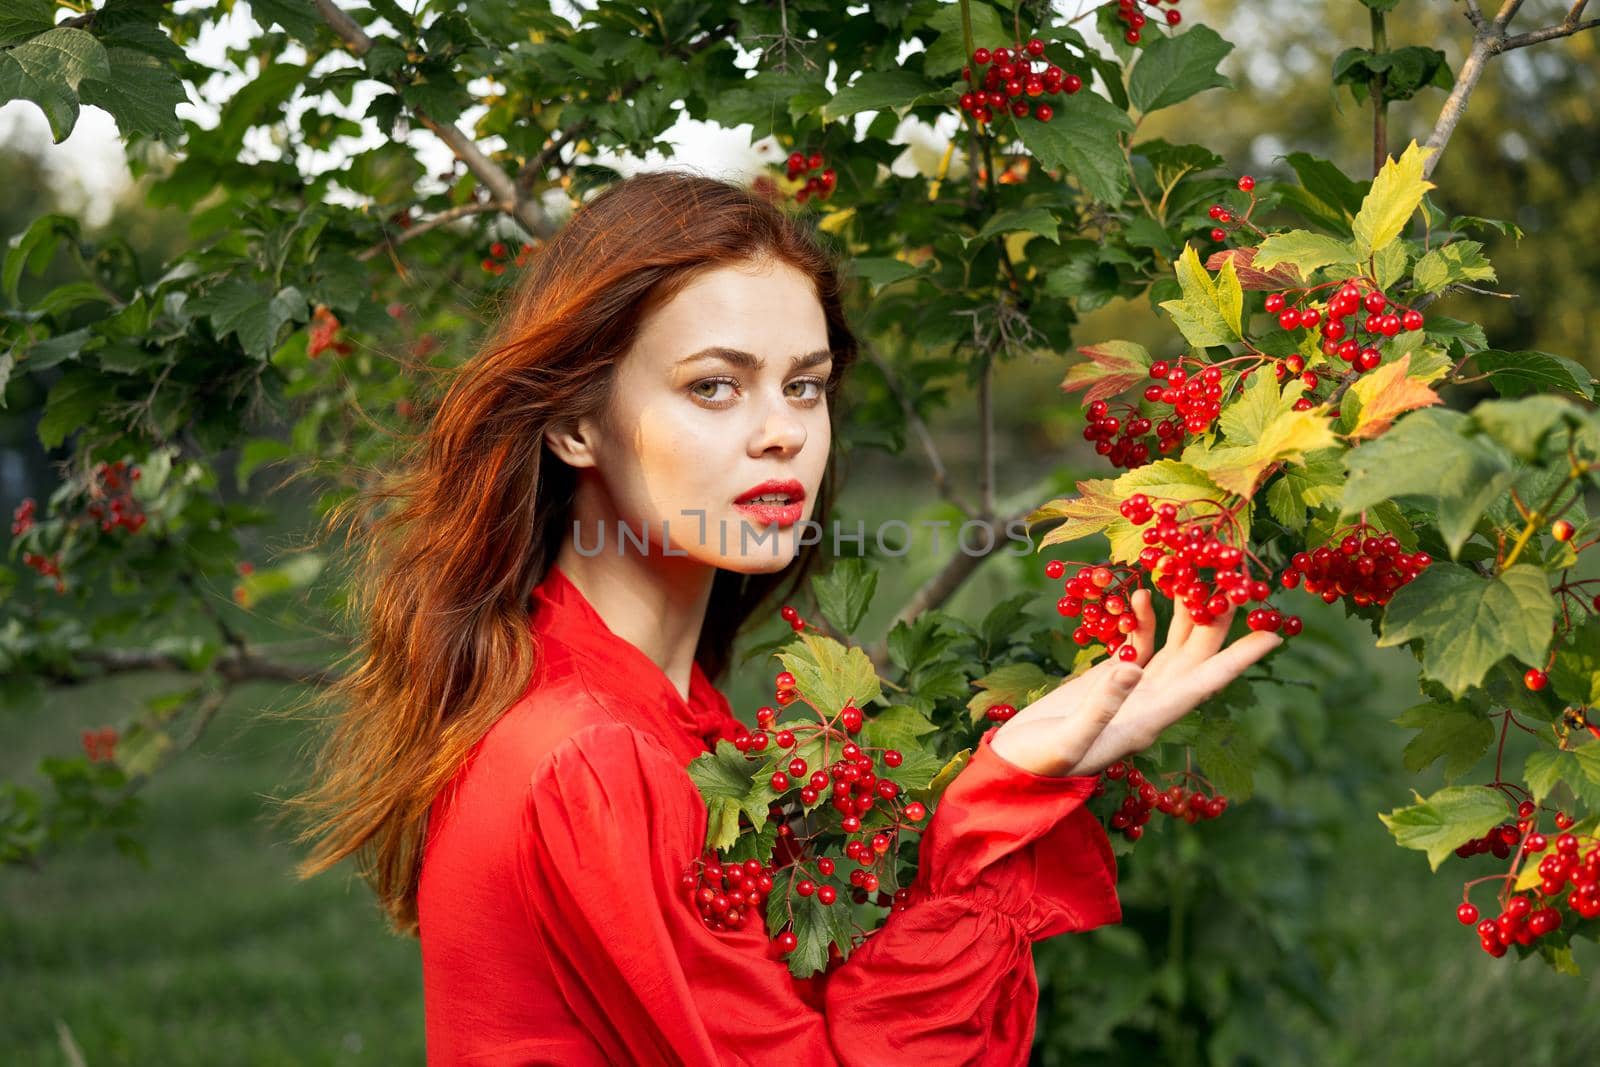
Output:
[517, 723, 1120, 1067]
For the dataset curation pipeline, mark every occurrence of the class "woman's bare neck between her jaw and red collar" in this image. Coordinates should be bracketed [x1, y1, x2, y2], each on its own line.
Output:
[555, 515, 717, 701]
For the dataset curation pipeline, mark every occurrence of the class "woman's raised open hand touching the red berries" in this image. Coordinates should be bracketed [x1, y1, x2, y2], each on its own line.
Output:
[989, 589, 1283, 776]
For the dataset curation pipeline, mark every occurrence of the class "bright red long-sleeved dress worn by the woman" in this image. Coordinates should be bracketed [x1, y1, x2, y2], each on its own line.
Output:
[418, 566, 1122, 1067]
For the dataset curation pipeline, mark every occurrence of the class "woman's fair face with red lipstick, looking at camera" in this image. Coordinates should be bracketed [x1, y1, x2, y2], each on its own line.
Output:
[552, 259, 832, 573]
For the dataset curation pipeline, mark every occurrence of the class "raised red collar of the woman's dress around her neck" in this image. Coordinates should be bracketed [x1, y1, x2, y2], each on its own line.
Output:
[530, 563, 733, 745]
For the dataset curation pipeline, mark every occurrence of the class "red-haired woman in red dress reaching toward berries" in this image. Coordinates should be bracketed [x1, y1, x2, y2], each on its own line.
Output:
[288, 173, 1280, 1064]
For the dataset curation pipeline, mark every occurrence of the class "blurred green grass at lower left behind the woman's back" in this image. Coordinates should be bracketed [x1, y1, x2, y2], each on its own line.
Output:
[0, 678, 422, 1067]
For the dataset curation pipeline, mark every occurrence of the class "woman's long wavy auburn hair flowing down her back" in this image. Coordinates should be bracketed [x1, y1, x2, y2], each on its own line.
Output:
[283, 171, 858, 937]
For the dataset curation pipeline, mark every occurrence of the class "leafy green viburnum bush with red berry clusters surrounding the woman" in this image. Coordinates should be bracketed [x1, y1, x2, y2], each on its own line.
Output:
[0, 0, 1600, 1043]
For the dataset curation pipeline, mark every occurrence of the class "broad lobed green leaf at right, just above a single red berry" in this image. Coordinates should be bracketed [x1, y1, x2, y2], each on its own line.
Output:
[1378, 561, 1555, 697]
